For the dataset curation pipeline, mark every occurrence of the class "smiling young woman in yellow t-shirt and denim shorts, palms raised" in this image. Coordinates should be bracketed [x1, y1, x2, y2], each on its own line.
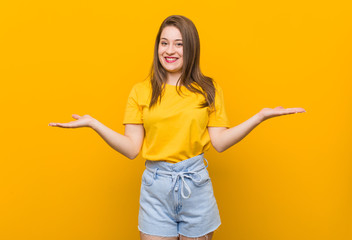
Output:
[49, 15, 305, 240]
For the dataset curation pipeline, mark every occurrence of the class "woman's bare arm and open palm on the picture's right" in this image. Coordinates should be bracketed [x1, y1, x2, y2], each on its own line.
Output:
[208, 106, 306, 152]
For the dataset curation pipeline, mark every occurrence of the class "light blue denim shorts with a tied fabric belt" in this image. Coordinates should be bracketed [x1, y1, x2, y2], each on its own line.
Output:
[138, 153, 221, 238]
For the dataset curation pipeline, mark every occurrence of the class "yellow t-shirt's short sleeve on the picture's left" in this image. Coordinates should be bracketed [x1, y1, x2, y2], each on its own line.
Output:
[122, 85, 143, 124]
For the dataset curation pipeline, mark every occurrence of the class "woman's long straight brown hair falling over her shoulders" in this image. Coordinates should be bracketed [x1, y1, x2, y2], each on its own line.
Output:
[149, 15, 215, 110]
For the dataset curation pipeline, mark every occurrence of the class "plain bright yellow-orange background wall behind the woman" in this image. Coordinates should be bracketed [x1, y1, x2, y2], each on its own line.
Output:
[0, 0, 352, 240]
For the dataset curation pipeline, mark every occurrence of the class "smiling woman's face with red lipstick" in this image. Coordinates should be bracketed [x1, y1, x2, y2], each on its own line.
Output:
[158, 26, 183, 73]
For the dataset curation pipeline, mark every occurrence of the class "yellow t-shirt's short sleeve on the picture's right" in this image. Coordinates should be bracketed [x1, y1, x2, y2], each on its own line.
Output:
[207, 83, 230, 128]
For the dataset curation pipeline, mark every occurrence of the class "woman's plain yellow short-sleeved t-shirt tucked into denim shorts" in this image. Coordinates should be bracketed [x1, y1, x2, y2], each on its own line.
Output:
[123, 78, 230, 163]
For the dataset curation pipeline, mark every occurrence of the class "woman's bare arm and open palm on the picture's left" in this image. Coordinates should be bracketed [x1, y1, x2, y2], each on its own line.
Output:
[49, 114, 144, 159]
